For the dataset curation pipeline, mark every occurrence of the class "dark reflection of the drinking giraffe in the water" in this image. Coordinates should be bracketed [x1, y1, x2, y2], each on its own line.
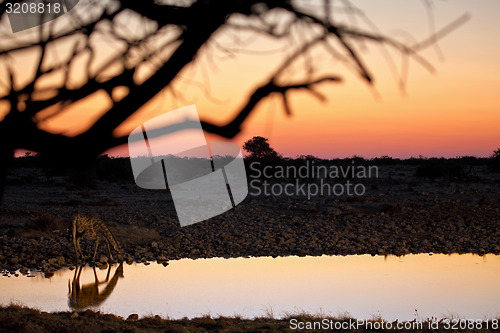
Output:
[68, 262, 124, 314]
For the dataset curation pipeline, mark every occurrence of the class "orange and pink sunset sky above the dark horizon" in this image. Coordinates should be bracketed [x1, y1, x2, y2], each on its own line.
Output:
[1, 0, 500, 158]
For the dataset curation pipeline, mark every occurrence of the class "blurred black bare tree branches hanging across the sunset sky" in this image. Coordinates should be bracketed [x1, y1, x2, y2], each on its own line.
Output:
[0, 0, 469, 201]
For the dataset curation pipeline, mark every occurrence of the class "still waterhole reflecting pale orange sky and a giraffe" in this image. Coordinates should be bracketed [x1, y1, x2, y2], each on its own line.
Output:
[0, 254, 500, 320]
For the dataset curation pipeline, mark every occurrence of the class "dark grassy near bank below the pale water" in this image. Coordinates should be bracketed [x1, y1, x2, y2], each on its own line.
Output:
[0, 306, 499, 333]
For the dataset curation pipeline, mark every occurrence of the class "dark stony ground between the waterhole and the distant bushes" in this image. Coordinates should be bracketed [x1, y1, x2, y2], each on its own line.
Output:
[0, 165, 500, 275]
